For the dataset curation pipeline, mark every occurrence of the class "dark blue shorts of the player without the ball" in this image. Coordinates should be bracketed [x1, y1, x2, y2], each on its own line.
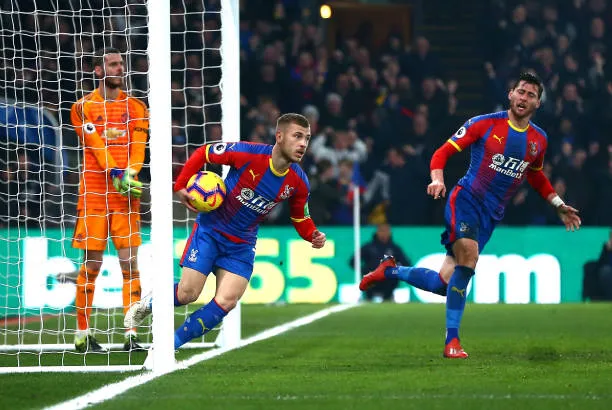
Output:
[441, 185, 497, 256]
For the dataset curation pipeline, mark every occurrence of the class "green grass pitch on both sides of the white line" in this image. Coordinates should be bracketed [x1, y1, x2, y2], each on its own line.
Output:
[0, 304, 612, 410]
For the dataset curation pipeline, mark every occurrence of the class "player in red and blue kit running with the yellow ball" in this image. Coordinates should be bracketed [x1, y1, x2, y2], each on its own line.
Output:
[124, 113, 326, 349]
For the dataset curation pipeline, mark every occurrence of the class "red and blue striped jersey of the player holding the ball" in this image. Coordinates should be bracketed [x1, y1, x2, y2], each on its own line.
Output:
[174, 142, 315, 244]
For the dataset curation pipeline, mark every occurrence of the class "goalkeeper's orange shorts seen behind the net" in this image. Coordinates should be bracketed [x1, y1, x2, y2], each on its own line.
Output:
[72, 209, 142, 251]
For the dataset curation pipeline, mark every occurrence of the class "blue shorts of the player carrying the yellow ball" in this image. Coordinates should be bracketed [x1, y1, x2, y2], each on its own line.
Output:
[180, 222, 255, 280]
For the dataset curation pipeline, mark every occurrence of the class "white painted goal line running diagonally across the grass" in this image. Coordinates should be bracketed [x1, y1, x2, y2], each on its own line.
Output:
[45, 304, 358, 410]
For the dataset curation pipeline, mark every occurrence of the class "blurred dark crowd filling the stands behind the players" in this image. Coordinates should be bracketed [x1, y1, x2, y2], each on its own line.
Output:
[0, 0, 612, 226]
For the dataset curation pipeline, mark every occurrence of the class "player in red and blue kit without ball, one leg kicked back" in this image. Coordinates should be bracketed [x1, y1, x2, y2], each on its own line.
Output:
[359, 73, 581, 359]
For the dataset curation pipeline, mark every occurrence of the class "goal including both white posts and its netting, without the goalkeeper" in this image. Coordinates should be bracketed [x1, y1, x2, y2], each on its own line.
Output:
[0, 0, 240, 372]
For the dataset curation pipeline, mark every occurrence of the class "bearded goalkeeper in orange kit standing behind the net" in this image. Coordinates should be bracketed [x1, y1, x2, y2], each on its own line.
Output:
[70, 48, 149, 352]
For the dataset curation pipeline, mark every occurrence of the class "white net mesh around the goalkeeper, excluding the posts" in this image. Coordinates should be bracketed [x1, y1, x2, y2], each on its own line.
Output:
[0, 0, 227, 367]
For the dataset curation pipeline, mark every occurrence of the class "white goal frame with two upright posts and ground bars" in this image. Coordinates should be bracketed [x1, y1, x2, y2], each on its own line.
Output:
[0, 0, 241, 374]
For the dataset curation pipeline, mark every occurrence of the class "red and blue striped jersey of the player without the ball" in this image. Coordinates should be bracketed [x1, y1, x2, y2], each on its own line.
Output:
[448, 111, 548, 220]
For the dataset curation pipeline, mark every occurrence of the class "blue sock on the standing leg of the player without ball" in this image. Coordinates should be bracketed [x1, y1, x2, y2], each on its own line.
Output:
[446, 265, 474, 343]
